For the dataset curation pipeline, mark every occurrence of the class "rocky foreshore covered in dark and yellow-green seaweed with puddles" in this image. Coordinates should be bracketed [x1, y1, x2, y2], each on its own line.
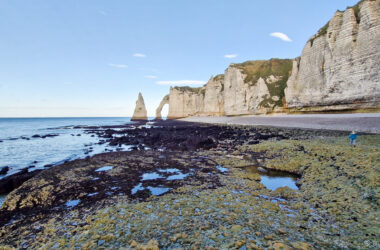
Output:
[0, 121, 380, 249]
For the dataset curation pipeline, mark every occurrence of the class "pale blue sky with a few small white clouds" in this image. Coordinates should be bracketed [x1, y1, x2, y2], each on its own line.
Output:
[0, 0, 357, 117]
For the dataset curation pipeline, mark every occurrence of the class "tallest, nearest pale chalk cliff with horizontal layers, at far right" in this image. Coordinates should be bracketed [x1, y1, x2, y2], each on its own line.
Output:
[285, 0, 380, 111]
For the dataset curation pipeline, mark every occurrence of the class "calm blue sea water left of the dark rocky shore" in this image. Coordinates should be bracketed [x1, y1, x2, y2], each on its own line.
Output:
[0, 117, 134, 179]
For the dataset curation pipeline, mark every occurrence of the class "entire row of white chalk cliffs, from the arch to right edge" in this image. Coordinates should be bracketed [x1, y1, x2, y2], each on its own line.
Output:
[157, 0, 380, 118]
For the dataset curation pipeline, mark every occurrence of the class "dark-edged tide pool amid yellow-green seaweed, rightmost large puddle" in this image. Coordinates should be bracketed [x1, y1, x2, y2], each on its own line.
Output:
[247, 166, 298, 190]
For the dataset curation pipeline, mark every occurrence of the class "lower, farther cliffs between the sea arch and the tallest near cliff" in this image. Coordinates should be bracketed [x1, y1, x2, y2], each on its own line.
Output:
[162, 59, 292, 119]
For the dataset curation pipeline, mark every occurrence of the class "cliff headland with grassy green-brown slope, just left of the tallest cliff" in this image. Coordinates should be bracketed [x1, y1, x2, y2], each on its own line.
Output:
[224, 59, 292, 115]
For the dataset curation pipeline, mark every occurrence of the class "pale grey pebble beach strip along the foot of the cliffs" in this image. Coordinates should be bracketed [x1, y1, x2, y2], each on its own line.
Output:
[180, 113, 380, 134]
